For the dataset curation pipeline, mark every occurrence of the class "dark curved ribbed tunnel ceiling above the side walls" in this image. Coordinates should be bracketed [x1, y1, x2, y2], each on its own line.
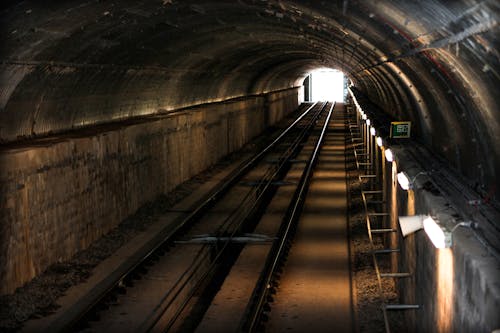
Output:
[0, 0, 500, 195]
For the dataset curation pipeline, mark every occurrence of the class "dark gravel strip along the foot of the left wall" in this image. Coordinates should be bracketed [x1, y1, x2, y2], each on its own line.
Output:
[0, 129, 274, 332]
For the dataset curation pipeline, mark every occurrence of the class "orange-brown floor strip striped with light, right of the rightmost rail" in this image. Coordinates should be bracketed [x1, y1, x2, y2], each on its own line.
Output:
[266, 103, 352, 332]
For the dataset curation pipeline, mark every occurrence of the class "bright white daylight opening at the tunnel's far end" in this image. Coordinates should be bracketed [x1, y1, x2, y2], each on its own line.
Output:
[304, 68, 345, 102]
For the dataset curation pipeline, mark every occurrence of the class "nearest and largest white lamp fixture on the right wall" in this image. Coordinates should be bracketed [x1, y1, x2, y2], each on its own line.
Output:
[398, 215, 477, 249]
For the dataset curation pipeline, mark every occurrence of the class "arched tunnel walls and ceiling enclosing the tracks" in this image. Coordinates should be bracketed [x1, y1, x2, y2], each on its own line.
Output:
[0, 0, 500, 332]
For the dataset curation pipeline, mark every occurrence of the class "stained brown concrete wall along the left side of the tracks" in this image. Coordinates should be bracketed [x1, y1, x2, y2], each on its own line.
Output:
[0, 88, 299, 294]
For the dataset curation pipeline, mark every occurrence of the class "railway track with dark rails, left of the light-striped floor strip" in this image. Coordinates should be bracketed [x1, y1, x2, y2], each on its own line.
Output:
[24, 103, 352, 332]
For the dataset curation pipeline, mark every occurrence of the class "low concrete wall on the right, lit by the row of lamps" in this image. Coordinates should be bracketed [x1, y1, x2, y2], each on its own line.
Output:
[348, 89, 500, 332]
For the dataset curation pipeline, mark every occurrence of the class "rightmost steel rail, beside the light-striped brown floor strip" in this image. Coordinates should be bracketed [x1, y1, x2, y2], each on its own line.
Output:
[239, 103, 335, 332]
